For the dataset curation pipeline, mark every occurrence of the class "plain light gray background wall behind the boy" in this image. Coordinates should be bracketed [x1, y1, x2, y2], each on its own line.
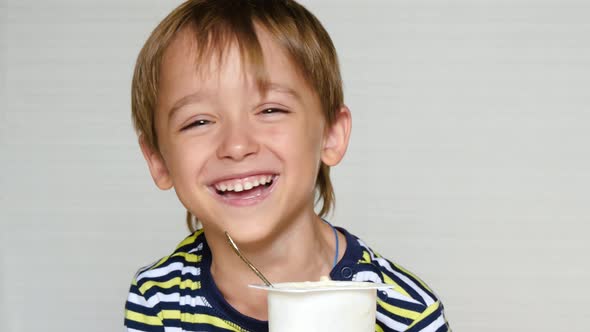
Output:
[0, 0, 590, 332]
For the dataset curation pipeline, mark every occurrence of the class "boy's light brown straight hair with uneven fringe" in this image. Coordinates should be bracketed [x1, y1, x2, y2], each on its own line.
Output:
[131, 0, 343, 231]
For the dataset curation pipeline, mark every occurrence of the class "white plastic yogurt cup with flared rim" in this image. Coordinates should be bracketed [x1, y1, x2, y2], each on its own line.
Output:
[250, 280, 392, 332]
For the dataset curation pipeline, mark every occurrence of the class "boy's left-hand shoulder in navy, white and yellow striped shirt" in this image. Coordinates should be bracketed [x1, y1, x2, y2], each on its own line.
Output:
[124, 230, 247, 331]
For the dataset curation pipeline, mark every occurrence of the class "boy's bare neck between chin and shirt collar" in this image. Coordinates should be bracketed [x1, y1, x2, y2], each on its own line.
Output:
[206, 211, 345, 320]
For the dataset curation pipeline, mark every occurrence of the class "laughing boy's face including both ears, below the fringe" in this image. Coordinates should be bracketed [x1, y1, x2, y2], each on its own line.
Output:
[140, 26, 350, 242]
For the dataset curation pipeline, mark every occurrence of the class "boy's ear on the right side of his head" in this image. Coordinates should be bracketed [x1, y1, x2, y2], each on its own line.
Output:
[321, 105, 352, 166]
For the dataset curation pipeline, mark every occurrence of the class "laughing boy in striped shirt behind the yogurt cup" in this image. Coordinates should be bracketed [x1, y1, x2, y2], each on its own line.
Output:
[125, 0, 448, 332]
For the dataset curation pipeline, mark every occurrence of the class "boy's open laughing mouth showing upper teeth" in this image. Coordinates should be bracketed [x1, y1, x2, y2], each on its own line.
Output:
[212, 174, 278, 205]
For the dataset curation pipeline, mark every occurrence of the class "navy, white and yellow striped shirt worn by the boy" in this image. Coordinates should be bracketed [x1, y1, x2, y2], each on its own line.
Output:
[125, 228, 450, 332]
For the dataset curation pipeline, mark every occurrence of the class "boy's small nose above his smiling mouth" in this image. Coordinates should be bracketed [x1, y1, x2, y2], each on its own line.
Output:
[217, 123, 259, 161]
